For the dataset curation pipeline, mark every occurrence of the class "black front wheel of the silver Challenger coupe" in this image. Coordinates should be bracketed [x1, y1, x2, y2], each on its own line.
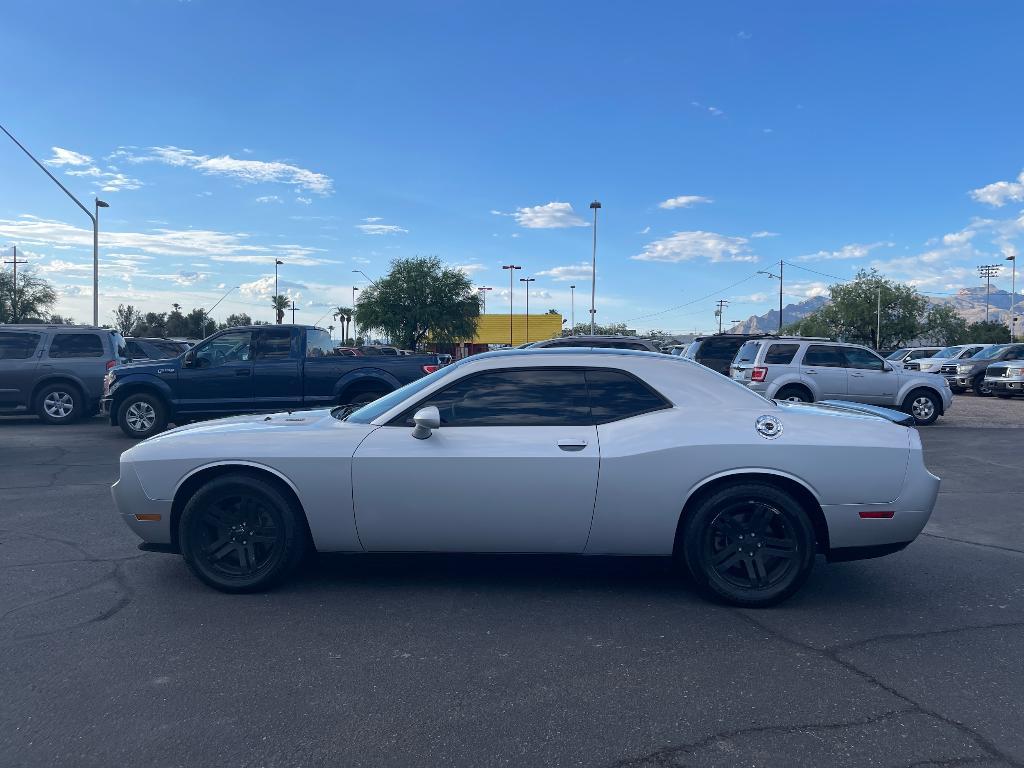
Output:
[178, 474, 306, 593]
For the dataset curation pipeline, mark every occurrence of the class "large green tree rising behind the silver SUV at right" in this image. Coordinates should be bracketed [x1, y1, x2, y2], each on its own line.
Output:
[782, 269, 928, 349]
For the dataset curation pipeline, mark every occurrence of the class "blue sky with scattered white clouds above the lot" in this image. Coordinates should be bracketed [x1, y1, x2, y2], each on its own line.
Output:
[0, 0, 1024, 332]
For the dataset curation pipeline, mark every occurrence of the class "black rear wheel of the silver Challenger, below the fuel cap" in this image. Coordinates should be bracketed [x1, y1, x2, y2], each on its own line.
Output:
[676, 482, 815, 608]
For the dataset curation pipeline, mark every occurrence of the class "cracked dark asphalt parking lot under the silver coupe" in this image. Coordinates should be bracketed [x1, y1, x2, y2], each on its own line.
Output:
[0, 395, 1024, 767]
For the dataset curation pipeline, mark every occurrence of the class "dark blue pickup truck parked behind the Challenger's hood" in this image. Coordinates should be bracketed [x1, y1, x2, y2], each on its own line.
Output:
[100, 325, 438, 437]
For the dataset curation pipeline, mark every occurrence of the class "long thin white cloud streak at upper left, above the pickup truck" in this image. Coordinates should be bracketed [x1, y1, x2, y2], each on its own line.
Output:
[118, 146, 334, 195]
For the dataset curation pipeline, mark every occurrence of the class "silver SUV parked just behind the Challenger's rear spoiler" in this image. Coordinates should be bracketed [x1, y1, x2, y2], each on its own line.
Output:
[730, 337, 953, 424]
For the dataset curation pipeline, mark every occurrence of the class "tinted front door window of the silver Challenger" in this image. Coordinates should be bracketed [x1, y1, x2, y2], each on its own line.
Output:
[401, 368, 591, 427]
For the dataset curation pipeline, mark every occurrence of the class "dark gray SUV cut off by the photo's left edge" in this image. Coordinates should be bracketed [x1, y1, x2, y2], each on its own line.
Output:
[0, 325, 128, 424]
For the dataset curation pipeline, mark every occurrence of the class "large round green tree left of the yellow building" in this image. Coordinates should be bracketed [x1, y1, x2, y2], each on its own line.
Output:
[353, 256, 480, 349]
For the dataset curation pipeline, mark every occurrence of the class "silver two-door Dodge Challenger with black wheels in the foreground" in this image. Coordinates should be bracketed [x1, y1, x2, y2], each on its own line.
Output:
[113, 348, 939, 606]
